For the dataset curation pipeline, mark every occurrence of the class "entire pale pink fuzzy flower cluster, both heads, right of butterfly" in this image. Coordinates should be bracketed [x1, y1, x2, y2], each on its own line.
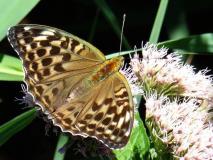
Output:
[124, 44, 213, 160]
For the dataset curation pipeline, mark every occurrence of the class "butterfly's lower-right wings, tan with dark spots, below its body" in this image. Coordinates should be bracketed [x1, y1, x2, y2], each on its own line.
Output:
[54, 72, 134, 148]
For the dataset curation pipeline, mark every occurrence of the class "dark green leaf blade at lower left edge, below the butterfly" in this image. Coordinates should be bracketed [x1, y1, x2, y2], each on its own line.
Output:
[0, 108, 36, 146]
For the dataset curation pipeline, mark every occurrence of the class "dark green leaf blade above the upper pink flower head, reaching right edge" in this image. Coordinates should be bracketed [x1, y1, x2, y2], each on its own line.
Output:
[158, 33, 213, 54]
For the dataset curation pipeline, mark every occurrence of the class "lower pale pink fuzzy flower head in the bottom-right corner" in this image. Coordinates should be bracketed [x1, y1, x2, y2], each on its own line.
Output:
[146, 96, 213, 160]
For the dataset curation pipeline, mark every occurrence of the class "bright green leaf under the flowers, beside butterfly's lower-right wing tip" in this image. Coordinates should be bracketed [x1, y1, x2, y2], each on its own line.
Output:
[113, 113, 150, 160]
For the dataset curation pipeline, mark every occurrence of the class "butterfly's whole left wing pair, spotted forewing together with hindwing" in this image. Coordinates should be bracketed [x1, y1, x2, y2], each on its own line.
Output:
[8, 25, 105, 112]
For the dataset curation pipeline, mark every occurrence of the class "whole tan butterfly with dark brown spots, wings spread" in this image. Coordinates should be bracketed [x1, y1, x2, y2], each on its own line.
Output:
[8, 24, 134, 149]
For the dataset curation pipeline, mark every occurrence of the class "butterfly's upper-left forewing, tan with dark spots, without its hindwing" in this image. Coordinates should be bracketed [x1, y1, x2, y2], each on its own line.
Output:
[8, 25, 105, 83]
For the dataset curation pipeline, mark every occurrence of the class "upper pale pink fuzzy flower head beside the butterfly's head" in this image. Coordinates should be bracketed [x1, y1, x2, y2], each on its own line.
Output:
[129, 43, 213, 99]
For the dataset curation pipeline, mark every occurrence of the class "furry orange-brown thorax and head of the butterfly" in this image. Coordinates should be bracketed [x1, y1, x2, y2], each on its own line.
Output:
[89, 57, 123, 84]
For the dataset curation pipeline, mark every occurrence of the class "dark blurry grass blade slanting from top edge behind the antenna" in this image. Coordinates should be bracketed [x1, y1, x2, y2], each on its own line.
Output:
[94, 0, 130, 49]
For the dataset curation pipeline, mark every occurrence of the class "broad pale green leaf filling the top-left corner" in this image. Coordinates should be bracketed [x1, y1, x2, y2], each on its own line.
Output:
[0, 0, 39, 41]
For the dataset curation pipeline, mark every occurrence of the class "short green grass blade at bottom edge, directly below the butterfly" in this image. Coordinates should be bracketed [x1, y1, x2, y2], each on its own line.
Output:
[54, 133, 69, 160]
